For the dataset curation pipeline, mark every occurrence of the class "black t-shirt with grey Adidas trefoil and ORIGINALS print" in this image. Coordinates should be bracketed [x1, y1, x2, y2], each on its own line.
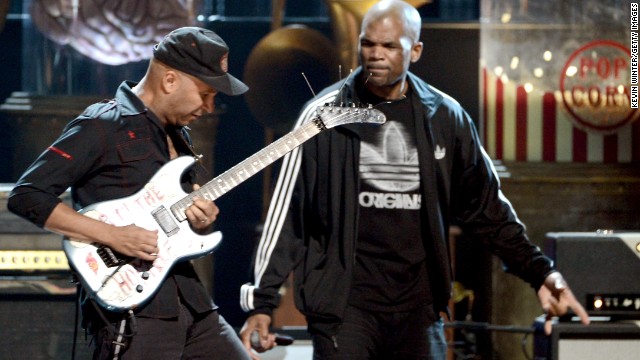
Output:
[349, 85, 431, 311]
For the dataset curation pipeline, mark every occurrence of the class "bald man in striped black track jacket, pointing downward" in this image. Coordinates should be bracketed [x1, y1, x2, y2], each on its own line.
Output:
[240, 0, 588, 360]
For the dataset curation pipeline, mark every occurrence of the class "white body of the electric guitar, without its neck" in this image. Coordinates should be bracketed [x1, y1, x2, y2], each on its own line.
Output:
[63, 156, 222, 311]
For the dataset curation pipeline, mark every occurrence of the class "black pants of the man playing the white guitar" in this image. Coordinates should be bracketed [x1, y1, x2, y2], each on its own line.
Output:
[93, 305, 250, 360]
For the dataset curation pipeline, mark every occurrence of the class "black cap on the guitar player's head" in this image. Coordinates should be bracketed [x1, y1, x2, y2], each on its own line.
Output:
[153, 27, 249, 95]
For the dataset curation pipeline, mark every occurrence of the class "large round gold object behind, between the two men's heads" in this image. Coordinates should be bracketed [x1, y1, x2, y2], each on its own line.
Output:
[243, 25, 339, 133]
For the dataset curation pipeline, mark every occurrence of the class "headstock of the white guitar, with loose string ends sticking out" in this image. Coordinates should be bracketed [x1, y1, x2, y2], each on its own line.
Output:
[316, 105, 387, 129]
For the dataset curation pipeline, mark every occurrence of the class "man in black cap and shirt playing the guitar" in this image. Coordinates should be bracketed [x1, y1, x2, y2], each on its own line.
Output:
[8, 27, 249, 359]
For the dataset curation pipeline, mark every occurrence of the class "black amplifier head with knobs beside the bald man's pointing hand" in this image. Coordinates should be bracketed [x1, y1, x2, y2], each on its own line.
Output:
[545, 231, 640, 319]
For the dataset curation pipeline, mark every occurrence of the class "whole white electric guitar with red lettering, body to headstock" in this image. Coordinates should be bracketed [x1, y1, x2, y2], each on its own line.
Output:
[63, 102, 386, 311]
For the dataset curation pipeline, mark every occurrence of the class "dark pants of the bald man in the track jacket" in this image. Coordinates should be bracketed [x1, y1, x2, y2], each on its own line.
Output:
[311, 306, 447, 360]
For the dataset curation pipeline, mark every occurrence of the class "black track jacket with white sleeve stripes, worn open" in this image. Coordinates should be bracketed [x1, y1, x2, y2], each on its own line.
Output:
[240, 68, 553, 335]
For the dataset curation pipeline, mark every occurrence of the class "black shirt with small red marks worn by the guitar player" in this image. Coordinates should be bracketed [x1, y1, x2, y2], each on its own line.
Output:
[7, 82, 215, 318]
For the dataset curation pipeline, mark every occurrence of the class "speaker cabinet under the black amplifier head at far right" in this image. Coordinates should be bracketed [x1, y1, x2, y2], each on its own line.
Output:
[534, 318, 640, 360]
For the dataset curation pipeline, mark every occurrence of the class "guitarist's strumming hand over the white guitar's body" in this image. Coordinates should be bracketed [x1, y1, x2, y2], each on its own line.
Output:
[105, 225, 160, 261]
